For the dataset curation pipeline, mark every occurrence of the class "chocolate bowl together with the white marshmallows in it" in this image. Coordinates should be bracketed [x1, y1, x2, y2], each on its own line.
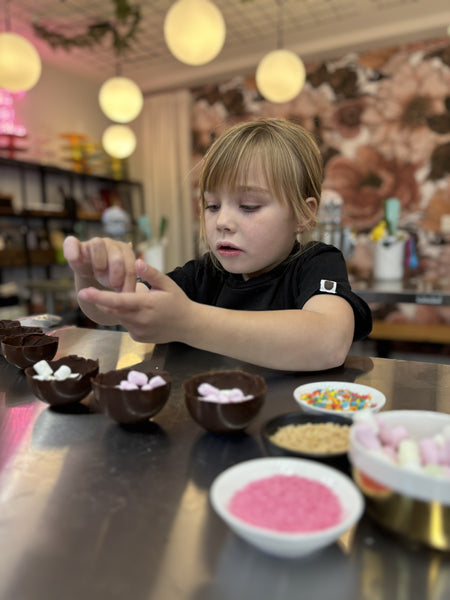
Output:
[25, 354, 99, 406]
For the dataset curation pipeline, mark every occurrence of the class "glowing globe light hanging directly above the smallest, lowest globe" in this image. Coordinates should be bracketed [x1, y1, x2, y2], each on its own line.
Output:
[98, 77, 144, 123]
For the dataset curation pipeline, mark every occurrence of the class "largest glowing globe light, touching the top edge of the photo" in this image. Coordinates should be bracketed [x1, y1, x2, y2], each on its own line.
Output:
[164, 0, 226, 66]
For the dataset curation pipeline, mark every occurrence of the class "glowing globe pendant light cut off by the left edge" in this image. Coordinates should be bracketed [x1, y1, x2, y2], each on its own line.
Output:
[0, 31, 42, 92]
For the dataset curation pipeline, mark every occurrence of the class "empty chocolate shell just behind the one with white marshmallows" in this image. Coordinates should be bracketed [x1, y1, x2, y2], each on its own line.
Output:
[1, 333, 59, 369]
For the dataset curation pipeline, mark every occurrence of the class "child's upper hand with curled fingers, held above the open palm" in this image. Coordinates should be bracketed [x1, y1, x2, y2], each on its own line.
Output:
[63, 236, 136, 292]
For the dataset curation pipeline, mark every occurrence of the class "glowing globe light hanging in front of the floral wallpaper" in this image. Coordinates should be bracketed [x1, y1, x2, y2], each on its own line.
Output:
[256, 49, 306, 102]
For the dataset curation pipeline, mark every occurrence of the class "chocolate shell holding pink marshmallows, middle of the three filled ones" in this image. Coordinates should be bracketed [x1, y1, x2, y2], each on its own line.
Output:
[92, 368, 172, 425]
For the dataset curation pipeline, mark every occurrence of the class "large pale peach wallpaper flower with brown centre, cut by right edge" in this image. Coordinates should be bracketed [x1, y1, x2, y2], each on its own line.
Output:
[361, 53, 450, 165]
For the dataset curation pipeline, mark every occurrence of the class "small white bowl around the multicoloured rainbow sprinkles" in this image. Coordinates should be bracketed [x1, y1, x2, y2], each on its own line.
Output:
[294, 381, 386, 419]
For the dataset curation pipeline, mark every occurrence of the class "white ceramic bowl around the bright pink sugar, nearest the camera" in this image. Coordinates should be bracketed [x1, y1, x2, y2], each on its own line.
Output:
[210, 458, 364, 558]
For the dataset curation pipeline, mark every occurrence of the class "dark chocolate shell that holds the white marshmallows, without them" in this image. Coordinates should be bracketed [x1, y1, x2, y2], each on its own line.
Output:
[25, 354, 99, 406]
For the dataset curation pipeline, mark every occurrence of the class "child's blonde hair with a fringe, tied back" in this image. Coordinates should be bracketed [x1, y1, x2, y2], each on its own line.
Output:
[199, 119, 323, 242]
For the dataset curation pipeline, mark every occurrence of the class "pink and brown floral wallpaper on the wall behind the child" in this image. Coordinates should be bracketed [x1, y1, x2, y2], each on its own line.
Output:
[192, 37, 450, 322]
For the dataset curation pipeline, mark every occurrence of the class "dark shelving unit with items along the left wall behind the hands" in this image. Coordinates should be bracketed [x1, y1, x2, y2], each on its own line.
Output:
[0, 157, 144, 314]
